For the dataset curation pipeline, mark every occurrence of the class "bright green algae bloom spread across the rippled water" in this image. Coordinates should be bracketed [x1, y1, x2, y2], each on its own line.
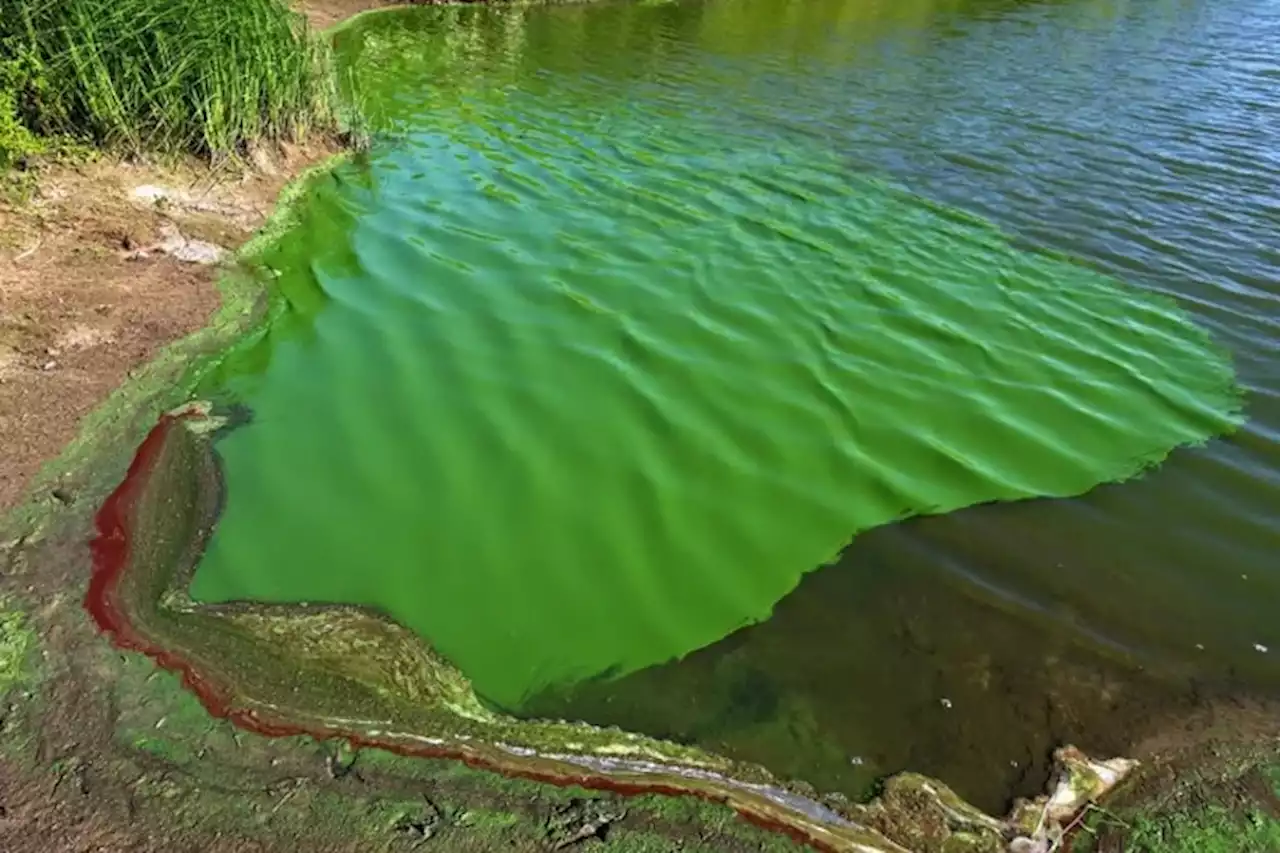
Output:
[183, 3, 1239, 710]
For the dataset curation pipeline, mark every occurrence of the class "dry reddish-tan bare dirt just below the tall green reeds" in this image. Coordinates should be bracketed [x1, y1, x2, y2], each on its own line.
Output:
[0, 143, 333, 514]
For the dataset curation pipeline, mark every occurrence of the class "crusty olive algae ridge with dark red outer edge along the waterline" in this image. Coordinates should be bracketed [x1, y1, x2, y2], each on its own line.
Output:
[74, 410, 1034, 853]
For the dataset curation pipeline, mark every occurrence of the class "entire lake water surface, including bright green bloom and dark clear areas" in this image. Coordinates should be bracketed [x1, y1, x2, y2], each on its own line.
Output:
[193, 0, 1280, 807]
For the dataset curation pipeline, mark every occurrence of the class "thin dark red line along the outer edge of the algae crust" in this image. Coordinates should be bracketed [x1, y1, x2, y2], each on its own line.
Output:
[84, 415, 832, 850]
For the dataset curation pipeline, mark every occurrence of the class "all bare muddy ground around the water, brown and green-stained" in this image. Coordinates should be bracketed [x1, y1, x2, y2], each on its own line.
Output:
[0, 0, 1280, 853]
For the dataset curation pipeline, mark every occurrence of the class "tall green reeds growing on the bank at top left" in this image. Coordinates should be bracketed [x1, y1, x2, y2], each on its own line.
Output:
[0, 0, 334, 155]
